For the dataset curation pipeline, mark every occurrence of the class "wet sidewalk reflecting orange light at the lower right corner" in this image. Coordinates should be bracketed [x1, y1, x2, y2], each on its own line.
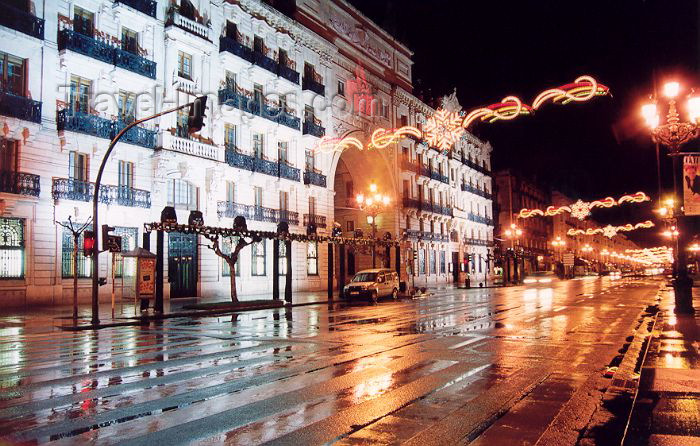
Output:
[624, 289, 700, 446]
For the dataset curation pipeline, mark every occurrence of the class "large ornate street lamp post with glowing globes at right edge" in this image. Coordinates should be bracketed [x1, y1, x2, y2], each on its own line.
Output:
[642, 82, 700, 314]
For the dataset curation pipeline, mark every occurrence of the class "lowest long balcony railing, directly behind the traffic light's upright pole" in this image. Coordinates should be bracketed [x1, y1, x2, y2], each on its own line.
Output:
[51, 178, 151, 208]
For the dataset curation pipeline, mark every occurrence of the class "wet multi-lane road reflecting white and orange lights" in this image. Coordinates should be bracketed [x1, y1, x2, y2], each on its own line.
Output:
[0, 278, 658, 446]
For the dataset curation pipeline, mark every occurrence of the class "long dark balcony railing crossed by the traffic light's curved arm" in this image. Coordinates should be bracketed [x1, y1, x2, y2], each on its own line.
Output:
[56, 109, 158, 149]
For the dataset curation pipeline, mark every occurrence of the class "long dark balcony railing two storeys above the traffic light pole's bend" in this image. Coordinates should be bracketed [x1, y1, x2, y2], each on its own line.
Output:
[58, 29, 156, 79]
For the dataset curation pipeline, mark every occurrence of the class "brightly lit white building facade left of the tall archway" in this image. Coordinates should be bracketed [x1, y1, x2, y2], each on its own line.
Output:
[0, 0, 337, 305]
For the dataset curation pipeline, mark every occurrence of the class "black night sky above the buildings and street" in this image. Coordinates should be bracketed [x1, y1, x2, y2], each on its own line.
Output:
[351, 0, 700, 244]
